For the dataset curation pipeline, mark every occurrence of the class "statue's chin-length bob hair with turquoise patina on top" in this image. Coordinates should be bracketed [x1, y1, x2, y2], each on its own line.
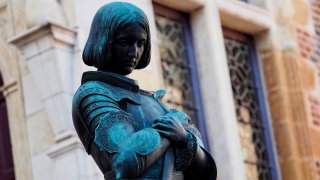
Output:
[82, 2, 151, 70]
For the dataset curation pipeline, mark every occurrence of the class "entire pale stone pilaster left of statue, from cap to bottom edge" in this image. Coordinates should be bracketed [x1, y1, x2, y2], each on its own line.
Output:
[10, 23, 102, 180]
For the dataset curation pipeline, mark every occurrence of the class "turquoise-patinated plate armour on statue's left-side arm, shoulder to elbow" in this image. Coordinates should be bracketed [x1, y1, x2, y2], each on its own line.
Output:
[73, 82, 160, 178]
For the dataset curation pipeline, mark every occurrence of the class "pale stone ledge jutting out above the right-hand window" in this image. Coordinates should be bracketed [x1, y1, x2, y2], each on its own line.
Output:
[217, 0, 274, 34]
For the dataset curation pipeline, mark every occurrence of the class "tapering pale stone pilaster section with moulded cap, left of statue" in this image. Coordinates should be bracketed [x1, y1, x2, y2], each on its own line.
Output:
[11, 23, 76, 142]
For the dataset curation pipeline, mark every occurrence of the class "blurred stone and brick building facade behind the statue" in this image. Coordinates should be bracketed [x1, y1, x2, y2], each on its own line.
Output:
[0, 0, 320, 180]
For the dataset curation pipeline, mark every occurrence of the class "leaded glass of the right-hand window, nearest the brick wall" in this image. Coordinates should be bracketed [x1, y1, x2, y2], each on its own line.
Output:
[224, 33, 271, 180]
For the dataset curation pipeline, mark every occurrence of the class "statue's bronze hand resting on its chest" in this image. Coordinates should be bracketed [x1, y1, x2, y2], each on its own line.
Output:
[152, 110, 189, 146]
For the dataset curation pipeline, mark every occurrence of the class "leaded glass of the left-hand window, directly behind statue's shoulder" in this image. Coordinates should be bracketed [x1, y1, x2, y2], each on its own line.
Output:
[155, 10, 197, 123]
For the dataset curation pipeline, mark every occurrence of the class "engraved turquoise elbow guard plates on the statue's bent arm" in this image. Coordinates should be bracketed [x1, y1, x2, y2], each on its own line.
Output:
[94, 111, 160, 155]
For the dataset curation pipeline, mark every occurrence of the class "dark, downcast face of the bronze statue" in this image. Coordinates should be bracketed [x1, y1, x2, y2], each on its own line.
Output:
[108, 23, 147, 75]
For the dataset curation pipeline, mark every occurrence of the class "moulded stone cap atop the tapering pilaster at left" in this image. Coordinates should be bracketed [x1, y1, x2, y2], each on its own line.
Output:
[8, 22, 77, 48]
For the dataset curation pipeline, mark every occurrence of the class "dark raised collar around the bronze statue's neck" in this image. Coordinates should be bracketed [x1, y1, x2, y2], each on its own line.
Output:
[81, 71, 139, 92]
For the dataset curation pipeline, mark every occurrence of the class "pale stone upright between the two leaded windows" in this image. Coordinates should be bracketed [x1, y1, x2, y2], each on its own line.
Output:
[191, 0, 246, 180]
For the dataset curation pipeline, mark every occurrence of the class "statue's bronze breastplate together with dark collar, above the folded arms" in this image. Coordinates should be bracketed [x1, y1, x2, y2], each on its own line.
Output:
[82, 72, 169, 130]
